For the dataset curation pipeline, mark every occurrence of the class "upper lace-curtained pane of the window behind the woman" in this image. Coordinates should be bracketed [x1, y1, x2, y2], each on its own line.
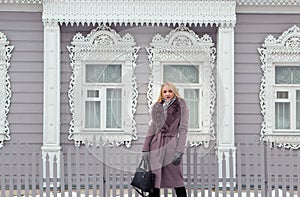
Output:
[164, 65, 199, 83]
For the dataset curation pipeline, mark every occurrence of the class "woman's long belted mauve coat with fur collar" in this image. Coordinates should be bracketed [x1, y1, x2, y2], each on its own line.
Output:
[143, 98, 188, 188]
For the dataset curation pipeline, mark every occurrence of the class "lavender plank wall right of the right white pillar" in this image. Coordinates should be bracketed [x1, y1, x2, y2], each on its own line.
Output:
[235, 14, 300, 175]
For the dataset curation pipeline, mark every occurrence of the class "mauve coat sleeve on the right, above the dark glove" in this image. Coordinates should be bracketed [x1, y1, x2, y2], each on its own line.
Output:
[176, 99, 189, 153]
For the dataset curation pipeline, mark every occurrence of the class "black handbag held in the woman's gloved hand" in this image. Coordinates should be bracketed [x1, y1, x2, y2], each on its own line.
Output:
[131, 158, 155, 197]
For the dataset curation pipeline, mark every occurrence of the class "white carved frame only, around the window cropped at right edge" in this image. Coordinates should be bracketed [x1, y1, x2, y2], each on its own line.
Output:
[258, 26, 300, 149]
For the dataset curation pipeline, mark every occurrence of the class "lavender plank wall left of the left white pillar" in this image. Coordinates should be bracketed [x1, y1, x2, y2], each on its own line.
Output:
[0, 12, 43, 146]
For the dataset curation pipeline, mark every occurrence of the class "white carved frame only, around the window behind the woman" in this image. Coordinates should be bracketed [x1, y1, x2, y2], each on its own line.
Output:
[147, 25, 216, 147]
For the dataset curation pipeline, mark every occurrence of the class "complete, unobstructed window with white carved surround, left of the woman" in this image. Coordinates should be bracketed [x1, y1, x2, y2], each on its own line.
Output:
[68, 26, 139, 147]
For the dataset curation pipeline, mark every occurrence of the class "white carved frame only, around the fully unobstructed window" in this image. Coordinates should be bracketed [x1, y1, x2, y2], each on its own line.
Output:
[68, 25, 139, 148]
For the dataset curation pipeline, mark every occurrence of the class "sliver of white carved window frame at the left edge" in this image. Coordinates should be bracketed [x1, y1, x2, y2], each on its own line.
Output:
[0, 32, 14, 148]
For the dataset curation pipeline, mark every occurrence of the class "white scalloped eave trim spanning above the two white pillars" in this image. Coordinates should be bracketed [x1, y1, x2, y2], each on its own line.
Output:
[43, 0, 236, 26]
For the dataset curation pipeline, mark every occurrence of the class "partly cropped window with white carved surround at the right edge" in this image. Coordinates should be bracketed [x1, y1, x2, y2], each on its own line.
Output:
[258, 26, 300, 149]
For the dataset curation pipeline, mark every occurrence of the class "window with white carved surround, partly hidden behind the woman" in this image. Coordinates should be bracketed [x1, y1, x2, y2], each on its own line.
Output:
[147, 26, 216, 147]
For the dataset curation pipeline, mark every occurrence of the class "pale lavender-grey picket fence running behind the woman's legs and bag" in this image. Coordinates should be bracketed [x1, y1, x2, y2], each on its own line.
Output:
[0, 142, 300, 197]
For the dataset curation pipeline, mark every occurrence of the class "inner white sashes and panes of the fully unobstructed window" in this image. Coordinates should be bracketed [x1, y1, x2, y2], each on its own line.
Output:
[83, 64, 124, 130]
